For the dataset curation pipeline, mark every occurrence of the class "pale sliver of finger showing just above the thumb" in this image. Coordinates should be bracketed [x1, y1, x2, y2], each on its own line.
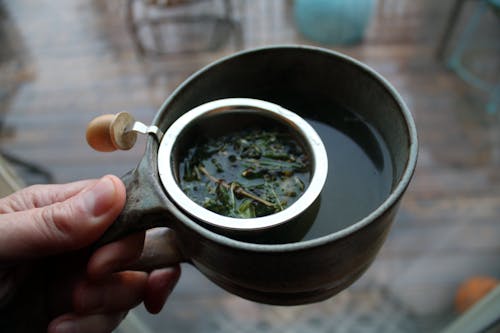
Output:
[0, 179, 97, 214]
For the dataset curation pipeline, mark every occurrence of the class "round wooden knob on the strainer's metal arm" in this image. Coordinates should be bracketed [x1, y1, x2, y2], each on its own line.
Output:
[86, 112, 137, 152]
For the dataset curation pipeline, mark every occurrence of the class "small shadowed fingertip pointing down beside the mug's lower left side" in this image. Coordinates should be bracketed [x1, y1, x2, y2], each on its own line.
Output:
[144, 265, 181, 314]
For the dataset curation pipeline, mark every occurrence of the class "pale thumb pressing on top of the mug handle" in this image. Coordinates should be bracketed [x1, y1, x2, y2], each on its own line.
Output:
[0, 176, 126, 262]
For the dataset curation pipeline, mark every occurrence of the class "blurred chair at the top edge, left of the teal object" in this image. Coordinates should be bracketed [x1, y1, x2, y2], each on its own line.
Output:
[127, 0, 241, 55]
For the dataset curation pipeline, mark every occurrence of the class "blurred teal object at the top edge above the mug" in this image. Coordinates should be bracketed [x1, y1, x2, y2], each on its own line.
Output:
[294, 0, 376, 45]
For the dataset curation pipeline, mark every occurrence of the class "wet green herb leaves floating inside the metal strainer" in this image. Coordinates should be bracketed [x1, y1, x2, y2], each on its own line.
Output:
[179, 129, 310, 218]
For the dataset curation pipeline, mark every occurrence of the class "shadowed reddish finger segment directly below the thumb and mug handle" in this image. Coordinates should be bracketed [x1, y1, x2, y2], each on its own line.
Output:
[87, 232, 145, 280]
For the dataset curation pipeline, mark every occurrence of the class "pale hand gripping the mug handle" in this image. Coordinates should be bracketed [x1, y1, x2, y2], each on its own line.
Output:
[0, 176, 180, 333]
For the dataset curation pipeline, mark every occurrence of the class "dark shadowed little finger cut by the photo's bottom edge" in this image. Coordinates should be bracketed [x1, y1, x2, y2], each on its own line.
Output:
[47, 312, 126, 333]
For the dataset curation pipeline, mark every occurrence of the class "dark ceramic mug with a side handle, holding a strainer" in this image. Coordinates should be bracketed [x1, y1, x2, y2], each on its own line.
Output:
[95, 46, 418, 305]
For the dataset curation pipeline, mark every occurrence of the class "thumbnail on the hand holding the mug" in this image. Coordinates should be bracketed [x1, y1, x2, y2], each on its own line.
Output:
[82, 177, 116, 216]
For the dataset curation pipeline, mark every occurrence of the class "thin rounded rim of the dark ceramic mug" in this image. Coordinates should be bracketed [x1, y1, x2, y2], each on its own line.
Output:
[148, 44, 418, 252]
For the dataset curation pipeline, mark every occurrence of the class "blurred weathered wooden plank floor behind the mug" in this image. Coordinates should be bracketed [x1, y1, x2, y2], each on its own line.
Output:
[0, 0, 500, 333]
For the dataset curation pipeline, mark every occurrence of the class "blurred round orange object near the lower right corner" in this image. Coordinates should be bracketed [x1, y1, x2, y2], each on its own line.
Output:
[455, 276, 499, 313]
